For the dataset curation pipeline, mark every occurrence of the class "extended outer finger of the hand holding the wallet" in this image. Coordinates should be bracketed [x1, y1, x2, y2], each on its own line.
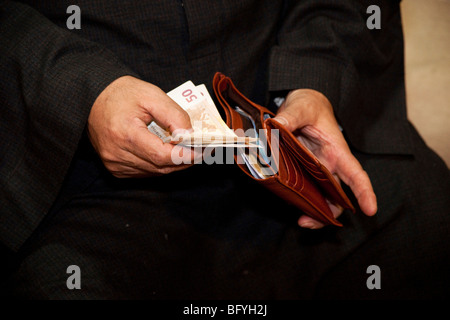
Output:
[335, 152, 377, 216]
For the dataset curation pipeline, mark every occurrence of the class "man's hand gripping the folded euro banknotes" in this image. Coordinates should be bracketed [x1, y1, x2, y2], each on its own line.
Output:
[87, 76, 194, 178]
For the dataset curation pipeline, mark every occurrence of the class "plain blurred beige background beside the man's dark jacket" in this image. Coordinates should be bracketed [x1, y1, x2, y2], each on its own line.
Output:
[400, 0, 450, 168]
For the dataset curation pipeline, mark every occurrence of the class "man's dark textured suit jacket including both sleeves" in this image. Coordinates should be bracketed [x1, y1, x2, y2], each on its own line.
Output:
[0, 0, 410, 250]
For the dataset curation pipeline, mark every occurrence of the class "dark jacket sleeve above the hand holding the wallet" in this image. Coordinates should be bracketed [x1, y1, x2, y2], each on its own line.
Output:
[269, 0, 411, 154]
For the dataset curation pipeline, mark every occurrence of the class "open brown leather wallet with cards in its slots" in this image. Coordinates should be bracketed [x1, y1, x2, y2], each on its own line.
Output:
[213, 72, 355, 226]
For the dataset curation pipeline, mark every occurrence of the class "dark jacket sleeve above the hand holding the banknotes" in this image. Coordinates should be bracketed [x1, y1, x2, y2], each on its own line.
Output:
[0, 1, 139, 250]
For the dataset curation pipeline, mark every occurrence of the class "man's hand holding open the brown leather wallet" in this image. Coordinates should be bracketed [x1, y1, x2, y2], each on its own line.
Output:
[275, 89, 377, 229]
